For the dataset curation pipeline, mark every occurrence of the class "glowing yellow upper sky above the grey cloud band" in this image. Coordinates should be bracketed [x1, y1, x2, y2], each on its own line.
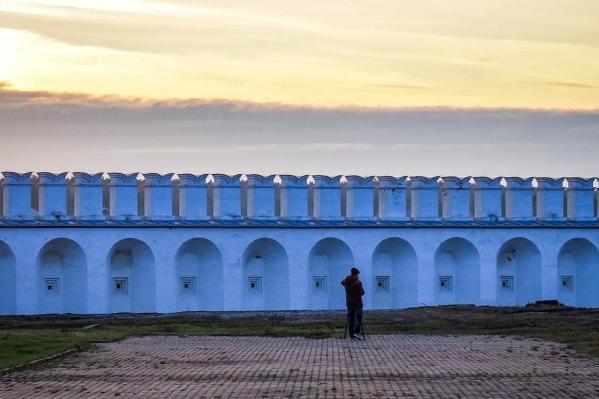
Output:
[0, 0, 599, 109]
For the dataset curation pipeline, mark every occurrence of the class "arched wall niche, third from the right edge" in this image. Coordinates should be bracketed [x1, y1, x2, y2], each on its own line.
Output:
[434, 237, 480, 305]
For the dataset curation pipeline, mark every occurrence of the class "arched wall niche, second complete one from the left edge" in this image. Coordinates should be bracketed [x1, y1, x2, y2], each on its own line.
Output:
[108, 238, 156, 313]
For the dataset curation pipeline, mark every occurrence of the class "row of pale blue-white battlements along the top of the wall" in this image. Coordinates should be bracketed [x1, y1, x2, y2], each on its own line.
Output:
[1, 172, 599, 221]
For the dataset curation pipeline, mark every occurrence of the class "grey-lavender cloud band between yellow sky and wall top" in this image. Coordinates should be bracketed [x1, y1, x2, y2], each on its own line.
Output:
[0, 82, 599, 176]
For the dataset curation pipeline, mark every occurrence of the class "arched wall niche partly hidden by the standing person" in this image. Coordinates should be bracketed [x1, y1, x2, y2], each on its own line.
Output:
[308, 238, 354, 309]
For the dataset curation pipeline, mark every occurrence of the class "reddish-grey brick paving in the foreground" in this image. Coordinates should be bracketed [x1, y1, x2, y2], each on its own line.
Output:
[0, 335, 599, 399]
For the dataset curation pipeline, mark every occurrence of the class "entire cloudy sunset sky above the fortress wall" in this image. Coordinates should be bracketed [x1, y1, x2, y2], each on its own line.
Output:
[0, 0, 599, 176]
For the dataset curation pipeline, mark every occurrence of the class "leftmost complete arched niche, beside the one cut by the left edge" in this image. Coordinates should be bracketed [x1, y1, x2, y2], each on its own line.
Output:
[37, 238, 87, 314]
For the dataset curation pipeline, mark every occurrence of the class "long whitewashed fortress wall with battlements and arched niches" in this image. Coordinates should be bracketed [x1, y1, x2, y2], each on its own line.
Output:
[0, 172, 599, 314]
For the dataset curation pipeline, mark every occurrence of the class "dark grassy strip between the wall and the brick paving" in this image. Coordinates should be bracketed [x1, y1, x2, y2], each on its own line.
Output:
[0, 305, 599, 369]
